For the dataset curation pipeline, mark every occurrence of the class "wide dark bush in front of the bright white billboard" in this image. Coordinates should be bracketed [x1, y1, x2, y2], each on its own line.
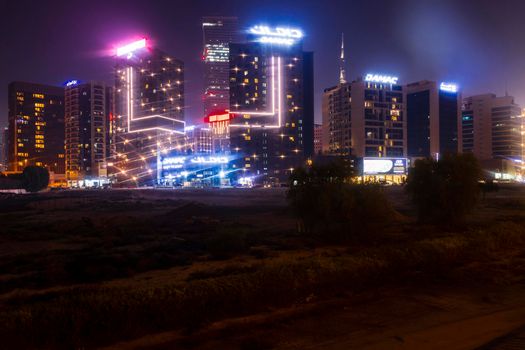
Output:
[287, 164, 395, 241]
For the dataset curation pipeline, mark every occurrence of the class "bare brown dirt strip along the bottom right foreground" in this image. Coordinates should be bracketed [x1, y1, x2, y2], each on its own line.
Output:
[101, 286, 525, 350]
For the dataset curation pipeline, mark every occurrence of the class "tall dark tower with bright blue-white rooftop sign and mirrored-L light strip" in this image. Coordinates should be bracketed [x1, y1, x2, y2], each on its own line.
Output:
[230, 26, 314, 183]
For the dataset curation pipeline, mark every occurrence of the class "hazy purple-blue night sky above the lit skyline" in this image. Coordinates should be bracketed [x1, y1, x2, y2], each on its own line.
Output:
[0, 0, 525, 126]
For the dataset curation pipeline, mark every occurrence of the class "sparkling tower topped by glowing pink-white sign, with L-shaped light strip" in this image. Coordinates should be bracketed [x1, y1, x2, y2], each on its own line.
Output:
[110, 39, 185, 185]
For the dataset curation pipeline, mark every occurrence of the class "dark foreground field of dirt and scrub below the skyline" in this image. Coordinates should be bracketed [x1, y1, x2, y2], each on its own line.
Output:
[0, 186, 525, 349]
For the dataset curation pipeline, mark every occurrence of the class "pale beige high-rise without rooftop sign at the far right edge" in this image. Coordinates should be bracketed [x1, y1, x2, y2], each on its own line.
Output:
[462, 94, 523, 161]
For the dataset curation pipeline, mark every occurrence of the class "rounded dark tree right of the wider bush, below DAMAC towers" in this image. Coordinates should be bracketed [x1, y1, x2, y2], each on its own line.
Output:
[406, 153, 481, 224]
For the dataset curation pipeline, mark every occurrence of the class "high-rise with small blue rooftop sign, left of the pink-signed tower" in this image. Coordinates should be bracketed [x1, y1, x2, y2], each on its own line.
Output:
[65, 80, 111, 185]
